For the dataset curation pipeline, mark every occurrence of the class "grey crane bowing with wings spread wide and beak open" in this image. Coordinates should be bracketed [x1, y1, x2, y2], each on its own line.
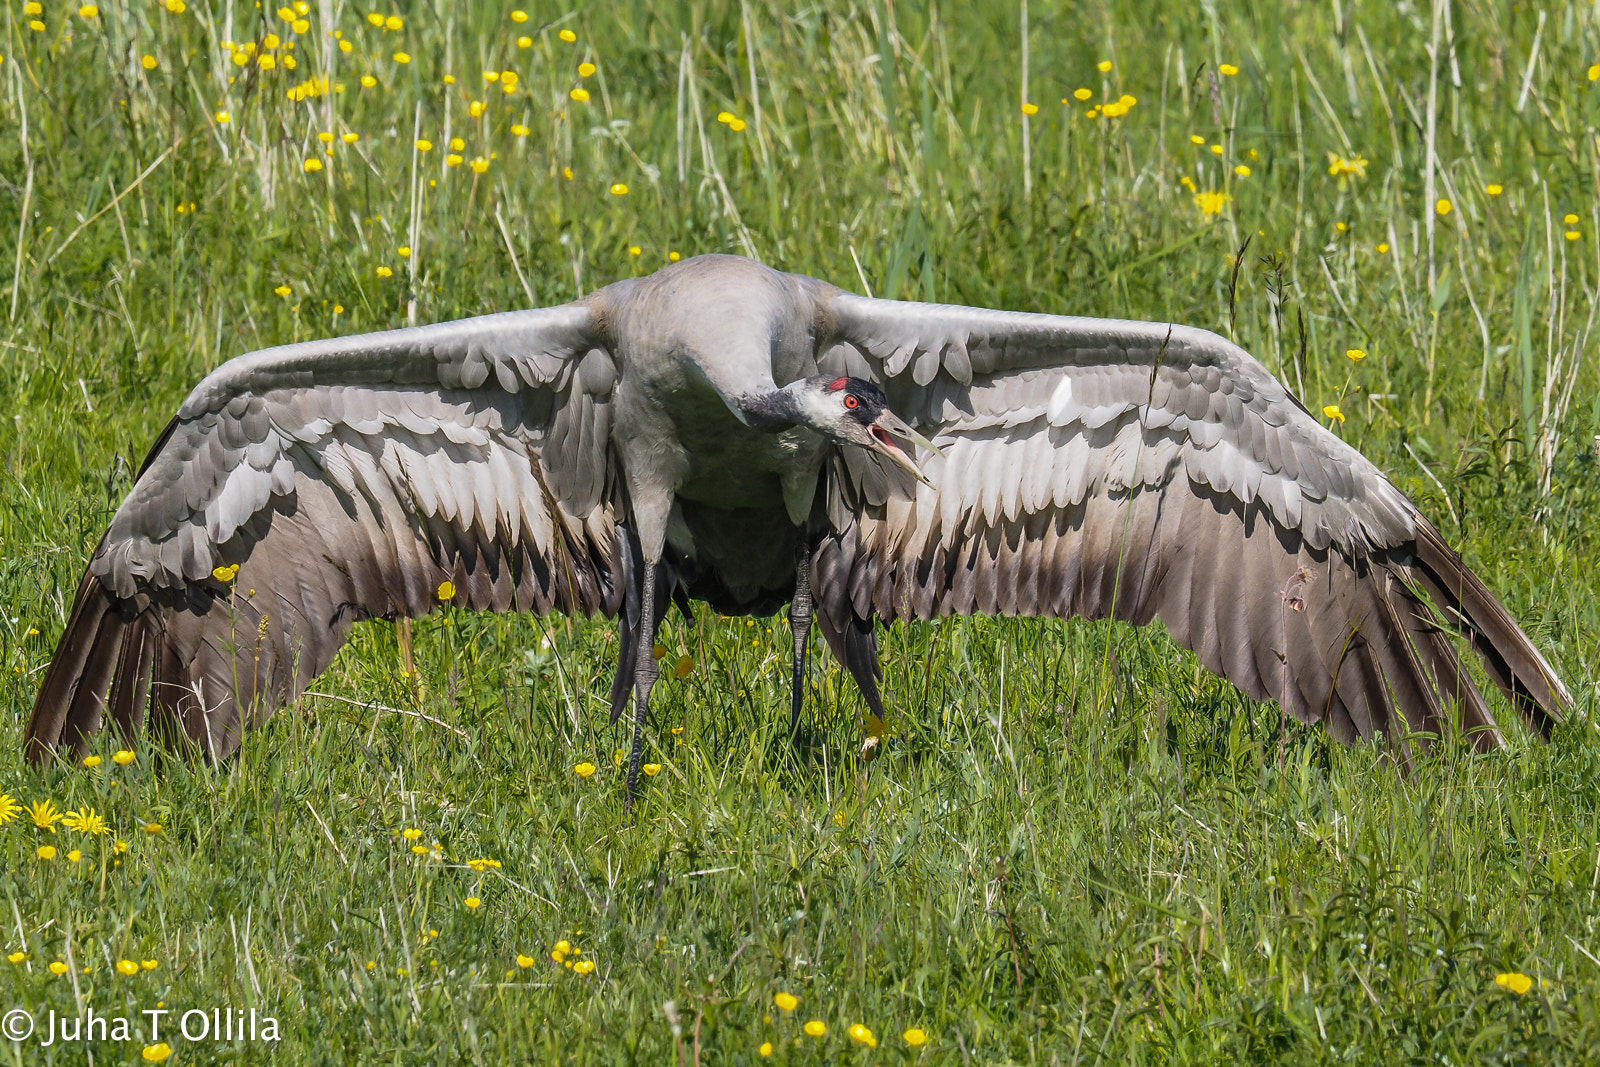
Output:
[27, 256, 1570, 780]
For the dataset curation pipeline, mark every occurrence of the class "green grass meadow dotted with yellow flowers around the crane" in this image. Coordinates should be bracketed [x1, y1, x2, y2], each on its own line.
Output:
[0, 0, 1600, 1065]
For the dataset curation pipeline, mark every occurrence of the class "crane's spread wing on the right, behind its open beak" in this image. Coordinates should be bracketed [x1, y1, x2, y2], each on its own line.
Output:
[813, 294, 1571, 747]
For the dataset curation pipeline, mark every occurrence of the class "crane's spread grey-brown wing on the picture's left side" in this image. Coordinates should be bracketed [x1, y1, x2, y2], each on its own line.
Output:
[27, 304, 622, 760]
